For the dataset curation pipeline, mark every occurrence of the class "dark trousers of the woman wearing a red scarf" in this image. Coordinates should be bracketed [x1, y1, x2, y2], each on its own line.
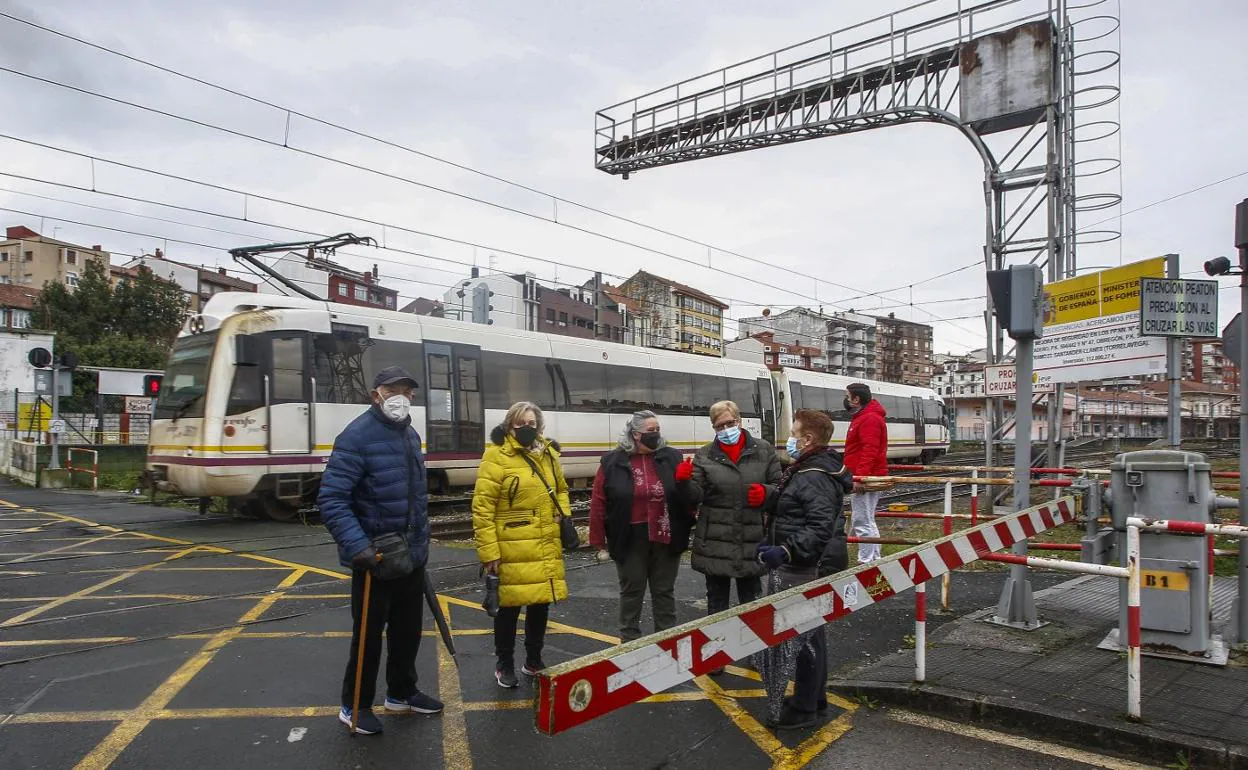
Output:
[615, 524, 680, 641]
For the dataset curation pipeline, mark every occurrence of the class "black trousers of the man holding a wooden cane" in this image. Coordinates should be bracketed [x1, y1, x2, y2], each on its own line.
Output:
[342, 569, 424, 709]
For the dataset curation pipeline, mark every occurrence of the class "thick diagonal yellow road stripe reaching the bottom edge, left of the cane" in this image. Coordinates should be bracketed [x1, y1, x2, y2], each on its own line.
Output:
[76, 569, 307, 770]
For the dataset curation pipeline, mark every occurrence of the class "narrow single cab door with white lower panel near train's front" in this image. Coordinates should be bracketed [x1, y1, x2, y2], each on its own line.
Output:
[265, 332, 316, 454]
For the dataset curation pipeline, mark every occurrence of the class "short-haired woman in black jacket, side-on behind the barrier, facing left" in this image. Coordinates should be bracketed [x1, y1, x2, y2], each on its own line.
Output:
[758, 409, 852, 730]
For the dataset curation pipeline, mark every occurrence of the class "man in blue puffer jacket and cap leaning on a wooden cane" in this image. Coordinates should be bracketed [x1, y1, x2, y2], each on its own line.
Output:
[317, 367, 442, 735]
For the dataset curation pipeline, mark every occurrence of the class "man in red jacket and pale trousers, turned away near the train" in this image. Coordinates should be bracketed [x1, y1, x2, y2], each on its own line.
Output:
[845, 382, 889, 564]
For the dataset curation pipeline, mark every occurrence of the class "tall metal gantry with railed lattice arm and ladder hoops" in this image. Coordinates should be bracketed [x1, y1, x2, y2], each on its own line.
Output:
[594, 0, 1122, 623]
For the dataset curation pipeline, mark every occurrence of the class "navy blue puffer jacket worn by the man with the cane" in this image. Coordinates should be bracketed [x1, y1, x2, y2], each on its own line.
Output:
[317, 406, 429, 569]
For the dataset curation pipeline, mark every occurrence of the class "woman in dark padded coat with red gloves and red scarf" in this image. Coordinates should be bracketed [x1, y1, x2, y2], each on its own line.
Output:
[676, 401, 780, 675]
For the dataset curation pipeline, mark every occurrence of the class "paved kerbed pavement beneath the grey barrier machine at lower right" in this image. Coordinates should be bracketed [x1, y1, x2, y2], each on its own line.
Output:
[831, 577, 1248, 768]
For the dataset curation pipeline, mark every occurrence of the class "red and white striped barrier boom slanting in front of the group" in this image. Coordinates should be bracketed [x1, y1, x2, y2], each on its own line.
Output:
[537, 497, 1076, 735]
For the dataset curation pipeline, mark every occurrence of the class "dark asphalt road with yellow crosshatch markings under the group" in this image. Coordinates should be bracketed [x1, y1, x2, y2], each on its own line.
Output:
[0, 484, 1158, 770]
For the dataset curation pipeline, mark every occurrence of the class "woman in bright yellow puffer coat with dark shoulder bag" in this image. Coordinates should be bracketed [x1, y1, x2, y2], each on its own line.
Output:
[472, 401, 572, 689]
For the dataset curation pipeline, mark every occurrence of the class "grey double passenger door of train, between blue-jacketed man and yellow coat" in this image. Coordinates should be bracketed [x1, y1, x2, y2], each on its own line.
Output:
[424, 342, 476, 457]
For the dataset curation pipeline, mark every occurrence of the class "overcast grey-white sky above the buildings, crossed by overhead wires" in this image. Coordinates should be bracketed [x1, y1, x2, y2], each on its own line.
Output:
[0, 0, 1248, 351]
